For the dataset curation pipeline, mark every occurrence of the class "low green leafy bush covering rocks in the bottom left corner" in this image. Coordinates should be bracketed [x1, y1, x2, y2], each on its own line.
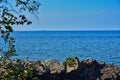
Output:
[0, 60, 38, 80]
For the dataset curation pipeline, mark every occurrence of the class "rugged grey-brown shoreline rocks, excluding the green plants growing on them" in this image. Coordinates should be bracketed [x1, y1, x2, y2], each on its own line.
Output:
[0, 57, 120, 80]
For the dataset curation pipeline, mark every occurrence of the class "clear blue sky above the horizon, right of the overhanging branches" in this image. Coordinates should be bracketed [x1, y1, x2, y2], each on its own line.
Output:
[15, 0, 120, 30]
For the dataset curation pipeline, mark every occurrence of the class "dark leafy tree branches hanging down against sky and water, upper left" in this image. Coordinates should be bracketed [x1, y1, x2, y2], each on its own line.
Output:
[0, 0, 41, 59]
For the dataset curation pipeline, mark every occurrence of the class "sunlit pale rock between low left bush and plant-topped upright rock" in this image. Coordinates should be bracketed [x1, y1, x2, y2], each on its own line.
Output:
[32, 60, 65, 75]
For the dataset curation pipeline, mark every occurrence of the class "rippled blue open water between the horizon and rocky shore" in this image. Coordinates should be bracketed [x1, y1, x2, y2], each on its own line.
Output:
[0, 31, 120, 65]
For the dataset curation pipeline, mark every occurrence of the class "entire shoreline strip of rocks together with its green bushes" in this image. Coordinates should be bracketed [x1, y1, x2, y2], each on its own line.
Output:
[0, 57, 120, 80]
